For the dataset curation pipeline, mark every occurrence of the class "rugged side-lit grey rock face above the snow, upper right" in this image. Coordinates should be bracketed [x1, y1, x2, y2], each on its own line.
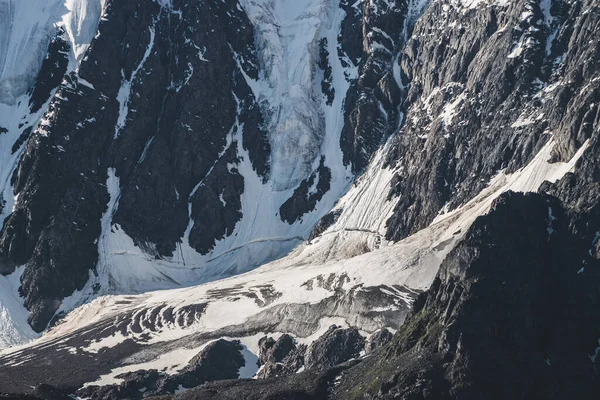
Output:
[387, 1, 599, 239]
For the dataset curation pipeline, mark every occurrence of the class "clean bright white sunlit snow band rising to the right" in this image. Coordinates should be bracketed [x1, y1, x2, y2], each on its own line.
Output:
[42, 140, 588, 341]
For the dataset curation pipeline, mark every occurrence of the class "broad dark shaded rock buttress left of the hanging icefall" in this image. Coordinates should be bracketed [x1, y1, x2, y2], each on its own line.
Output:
[0, 1, 269, 331]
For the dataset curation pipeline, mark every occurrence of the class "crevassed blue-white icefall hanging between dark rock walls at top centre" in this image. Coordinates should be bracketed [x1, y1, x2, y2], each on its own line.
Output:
[241, 0, 338, 190]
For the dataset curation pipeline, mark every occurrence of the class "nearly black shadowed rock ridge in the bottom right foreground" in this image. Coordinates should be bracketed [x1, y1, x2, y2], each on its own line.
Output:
[334, 194, 600, 399]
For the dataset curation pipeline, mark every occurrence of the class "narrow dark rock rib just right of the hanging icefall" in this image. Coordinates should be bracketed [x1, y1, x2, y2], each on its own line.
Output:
[338, 0, 410, 172]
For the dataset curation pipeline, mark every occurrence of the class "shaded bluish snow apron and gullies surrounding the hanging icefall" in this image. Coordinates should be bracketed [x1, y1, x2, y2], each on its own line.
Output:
[48, 1, 352, 304]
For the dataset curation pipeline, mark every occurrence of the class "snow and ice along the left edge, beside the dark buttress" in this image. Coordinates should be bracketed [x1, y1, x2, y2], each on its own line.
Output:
[0, 0, 105, 348]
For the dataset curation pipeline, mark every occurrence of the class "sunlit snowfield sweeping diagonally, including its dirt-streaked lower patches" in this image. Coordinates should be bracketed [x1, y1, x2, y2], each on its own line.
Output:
[2, 133, 588, 385]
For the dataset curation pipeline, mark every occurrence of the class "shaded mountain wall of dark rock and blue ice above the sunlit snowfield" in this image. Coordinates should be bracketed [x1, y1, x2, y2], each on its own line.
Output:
[0, 0, 414, 332]
